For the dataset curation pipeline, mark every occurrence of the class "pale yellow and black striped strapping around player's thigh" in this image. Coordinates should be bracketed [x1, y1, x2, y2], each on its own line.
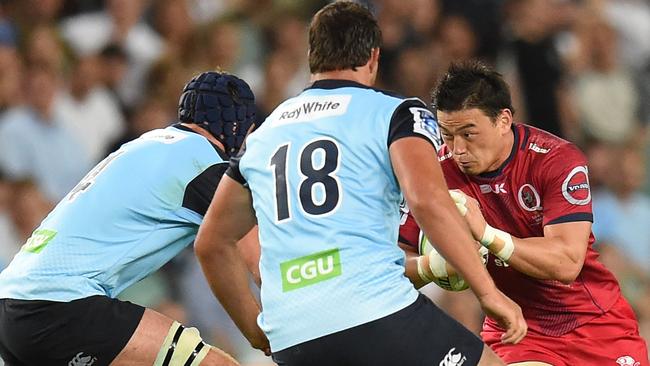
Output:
[153, 321, 218, 366]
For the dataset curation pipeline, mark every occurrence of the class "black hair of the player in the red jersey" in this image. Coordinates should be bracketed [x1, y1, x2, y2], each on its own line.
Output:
[431, 61, 515, 119]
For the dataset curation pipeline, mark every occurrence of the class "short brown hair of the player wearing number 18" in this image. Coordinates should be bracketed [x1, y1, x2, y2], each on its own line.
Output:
[309, 1, 381, 74]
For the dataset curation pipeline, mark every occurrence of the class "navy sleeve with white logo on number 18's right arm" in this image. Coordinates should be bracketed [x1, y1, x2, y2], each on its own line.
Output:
[388, 99, 442, 151]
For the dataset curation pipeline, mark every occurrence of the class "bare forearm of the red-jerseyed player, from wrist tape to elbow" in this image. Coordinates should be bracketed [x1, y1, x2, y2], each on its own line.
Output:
[508, 237, 584, 284]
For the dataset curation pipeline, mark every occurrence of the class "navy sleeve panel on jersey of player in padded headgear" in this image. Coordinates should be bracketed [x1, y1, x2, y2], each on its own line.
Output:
[183, 162, 228, 216]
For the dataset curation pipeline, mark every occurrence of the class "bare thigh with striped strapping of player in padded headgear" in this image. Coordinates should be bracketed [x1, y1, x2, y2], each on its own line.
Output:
[111, 309, 239, 366]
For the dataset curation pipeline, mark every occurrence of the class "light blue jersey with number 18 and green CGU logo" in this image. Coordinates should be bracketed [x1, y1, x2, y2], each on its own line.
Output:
[227, 80, 440, 351]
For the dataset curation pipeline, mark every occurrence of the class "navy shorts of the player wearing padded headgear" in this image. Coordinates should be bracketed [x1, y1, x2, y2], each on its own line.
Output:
[0, 296, 145, 366]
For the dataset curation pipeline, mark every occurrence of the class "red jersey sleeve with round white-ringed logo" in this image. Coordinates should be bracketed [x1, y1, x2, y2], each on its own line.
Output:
[536, 144, 593, 226]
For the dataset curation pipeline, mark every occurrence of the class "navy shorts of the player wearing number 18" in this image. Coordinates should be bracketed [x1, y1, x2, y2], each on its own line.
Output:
[273, 295, 483, 366]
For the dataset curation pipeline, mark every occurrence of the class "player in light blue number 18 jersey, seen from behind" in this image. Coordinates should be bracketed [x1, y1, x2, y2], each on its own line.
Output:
[195, 1, 526, 366]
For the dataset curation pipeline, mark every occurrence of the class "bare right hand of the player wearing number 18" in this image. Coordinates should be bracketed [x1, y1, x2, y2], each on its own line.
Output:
[478, 289, 528, 344]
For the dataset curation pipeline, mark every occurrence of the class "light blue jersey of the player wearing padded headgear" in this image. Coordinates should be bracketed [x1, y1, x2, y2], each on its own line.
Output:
[0, 125, 227, 301]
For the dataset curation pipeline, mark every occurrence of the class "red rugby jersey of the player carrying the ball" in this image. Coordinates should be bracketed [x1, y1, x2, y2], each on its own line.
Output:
[400, 124, 620, 336]
